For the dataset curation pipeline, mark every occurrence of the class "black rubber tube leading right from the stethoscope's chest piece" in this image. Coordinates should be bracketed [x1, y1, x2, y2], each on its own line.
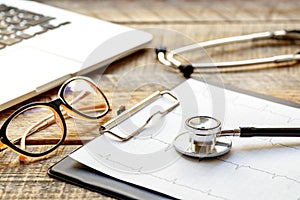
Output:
[240, 127, 300, 137]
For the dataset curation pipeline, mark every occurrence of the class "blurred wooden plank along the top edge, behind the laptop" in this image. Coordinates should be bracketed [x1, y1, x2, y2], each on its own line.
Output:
[36, 0, 300, 24]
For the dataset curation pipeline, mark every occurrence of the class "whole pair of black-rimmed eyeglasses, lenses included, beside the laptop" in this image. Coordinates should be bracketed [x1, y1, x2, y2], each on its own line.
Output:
[0, 76, 109, 160]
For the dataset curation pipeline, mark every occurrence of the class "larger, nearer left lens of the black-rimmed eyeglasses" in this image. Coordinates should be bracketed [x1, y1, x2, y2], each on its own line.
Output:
[6, 106, 64, 154]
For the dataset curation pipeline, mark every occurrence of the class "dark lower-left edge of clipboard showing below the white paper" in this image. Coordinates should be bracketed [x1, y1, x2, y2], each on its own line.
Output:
[48, 156, 174, 200]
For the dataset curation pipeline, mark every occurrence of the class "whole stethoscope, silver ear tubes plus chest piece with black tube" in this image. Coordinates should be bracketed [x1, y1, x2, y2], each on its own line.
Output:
[155, 30, 300, 158]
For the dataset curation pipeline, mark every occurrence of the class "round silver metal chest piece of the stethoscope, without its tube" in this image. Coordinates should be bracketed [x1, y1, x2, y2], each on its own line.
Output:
[174, 116, 232, 158]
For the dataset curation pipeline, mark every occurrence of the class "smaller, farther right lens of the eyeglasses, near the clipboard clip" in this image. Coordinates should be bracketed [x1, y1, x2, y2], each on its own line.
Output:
[63, 79, 107, 117]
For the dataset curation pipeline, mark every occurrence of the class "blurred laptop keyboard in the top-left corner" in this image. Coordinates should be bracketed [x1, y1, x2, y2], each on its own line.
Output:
[0, 4, 70, 49]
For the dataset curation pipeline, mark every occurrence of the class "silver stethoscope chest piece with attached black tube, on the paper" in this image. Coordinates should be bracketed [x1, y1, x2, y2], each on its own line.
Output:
[174, 116, 300, 158]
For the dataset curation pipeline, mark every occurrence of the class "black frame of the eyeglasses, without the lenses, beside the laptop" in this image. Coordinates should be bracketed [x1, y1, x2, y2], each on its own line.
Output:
[0, 76, 110, 157]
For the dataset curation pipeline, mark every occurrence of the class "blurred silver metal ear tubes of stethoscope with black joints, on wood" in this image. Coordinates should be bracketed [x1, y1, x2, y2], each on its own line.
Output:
[155, 30, 300, 78]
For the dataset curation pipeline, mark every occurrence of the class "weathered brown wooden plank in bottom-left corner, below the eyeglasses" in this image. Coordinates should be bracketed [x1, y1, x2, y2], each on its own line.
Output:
[0, 146, 110, 199]
